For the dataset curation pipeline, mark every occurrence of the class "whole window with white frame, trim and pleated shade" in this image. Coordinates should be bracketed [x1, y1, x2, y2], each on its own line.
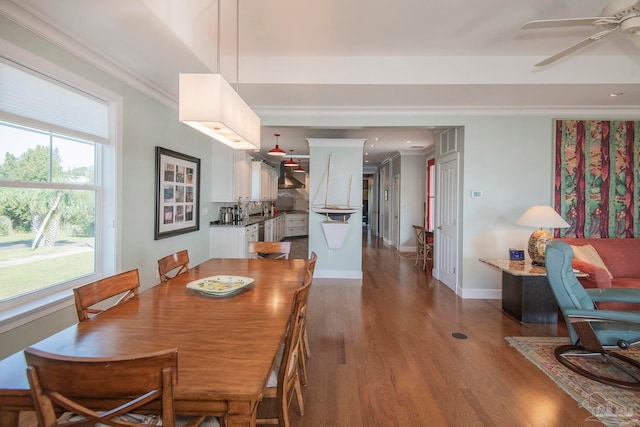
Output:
[0, 47, 117, 331]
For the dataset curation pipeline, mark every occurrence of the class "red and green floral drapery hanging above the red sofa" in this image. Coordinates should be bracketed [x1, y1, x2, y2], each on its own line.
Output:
[555, 120, 640, 238]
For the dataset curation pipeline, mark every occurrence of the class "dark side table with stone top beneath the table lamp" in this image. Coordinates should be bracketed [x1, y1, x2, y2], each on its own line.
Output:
[480, 259, 558, 323]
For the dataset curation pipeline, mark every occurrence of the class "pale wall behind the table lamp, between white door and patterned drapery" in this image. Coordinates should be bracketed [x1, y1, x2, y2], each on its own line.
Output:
[460, 116, 553, 298]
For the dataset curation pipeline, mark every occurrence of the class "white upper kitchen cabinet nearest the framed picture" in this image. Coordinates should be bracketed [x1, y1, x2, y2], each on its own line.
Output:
[211, 141, 252, 202]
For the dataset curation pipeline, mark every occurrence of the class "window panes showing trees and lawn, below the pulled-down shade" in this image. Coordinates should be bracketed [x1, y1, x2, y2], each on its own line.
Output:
[0, 122, 99, 301]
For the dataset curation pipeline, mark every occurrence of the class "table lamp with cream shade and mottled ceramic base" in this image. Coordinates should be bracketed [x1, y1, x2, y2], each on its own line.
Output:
[516, 205, 569, 265]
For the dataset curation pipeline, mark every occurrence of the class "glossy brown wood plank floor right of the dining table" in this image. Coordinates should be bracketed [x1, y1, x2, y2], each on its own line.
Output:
[290, 232, 601, 427]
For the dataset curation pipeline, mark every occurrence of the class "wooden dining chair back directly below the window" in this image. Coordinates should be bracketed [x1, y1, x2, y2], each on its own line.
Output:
[73, 269, 140, 322]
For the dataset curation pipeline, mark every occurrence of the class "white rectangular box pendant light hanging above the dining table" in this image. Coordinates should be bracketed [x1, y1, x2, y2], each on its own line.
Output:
[178, 74, 260, 150]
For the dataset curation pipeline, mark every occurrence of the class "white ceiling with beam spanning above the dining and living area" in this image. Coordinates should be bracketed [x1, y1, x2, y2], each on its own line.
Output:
[0, 0, 640, 164]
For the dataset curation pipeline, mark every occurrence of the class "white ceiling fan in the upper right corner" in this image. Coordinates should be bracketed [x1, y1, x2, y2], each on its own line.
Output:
[522, 0, 640, 67]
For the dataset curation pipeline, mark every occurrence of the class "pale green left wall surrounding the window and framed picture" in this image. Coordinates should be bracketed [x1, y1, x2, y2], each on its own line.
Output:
[0, 17, 212, 357]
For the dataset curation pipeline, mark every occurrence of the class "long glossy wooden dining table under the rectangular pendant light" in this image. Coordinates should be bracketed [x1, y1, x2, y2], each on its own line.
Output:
[0, 259, 307, 427]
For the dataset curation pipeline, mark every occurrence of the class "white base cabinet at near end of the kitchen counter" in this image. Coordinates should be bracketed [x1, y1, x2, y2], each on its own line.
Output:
[209, 224, 258, 258]
